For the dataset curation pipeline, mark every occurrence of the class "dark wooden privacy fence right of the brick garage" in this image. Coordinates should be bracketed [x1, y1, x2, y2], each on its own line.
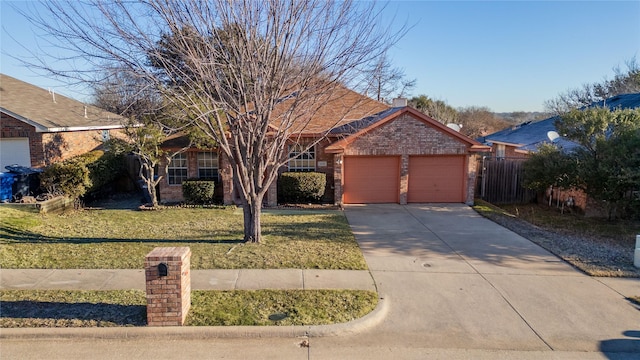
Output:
[477, 157, 537, 204]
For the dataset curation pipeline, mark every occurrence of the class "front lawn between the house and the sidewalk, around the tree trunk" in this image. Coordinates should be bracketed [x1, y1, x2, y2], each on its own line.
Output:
[0, 207, 366, 270]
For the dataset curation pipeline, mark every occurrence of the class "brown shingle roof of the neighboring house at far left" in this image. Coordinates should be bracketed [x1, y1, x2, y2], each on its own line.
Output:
[0, 74, 124, 132]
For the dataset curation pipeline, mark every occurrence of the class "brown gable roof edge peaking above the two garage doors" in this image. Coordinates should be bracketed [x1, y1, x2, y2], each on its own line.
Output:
[325, 106, 490, 153]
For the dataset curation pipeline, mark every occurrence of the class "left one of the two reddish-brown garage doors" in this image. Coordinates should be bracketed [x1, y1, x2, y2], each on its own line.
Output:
[343, 156, 400, 204]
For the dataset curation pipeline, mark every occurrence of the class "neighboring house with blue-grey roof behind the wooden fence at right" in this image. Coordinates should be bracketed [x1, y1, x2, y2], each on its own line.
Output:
[478, 93, 640, 158]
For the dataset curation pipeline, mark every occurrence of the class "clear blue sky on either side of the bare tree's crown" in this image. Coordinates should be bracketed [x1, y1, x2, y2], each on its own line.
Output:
[0, 0, 640, 112]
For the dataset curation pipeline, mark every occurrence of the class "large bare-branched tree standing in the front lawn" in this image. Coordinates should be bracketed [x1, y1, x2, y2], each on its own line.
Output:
[20, 0, 403, 242]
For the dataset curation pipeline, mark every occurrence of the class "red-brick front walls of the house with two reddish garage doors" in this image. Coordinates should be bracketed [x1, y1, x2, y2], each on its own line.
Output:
[158, 106, 489, 206]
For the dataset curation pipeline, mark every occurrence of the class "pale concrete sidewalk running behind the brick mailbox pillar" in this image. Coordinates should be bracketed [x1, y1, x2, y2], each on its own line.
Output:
[0, 269, 376, 291]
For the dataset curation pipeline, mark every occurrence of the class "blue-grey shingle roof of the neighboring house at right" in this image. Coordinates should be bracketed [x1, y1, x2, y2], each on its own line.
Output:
[479, 93, 640, 152]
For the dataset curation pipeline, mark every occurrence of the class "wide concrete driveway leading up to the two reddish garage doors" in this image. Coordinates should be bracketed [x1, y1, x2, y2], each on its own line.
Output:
[336, 204, 640, 353]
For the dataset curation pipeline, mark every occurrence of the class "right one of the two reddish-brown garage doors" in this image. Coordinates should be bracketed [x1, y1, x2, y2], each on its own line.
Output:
[407, 156, 465, 203]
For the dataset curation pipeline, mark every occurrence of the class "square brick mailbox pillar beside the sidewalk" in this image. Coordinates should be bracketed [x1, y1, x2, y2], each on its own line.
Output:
[144, 247, 191, 326]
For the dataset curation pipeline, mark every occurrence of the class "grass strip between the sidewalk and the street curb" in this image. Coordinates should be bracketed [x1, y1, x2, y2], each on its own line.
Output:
[0, 290, 378, 328]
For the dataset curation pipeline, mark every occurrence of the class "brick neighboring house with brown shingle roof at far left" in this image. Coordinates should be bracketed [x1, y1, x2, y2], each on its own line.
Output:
[0, 74, 123, 172]
